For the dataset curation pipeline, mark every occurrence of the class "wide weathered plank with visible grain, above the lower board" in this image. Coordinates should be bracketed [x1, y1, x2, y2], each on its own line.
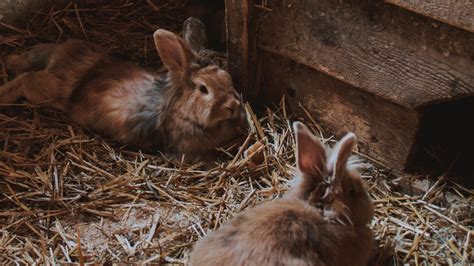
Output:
[257, 0, 474, 108]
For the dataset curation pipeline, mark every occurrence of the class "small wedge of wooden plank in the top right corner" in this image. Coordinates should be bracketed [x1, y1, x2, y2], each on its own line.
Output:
[385, 0, 474, 32]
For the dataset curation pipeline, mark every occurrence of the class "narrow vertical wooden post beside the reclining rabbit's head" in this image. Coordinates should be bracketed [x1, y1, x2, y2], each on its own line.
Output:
[225, 0, 255, 96]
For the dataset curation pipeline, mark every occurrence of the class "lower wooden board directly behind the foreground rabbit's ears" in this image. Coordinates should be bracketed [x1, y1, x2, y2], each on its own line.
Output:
[259, 52, 419, 170]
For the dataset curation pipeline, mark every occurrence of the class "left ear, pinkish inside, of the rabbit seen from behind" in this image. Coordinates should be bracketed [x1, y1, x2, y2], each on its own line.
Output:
[293, 122, 326, 176]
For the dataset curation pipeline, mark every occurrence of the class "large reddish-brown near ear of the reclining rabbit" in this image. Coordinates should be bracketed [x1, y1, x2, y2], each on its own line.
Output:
[153, 29, 194, 77]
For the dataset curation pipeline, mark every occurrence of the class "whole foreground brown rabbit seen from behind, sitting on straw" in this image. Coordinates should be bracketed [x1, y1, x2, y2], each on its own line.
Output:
[190, 122, 373, 266]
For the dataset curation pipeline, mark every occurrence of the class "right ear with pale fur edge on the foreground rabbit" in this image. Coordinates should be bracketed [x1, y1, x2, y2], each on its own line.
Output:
[328, 132, 356, 181]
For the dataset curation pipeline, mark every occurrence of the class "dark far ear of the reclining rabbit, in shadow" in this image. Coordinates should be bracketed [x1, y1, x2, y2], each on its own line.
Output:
[182, 17, 207, 53]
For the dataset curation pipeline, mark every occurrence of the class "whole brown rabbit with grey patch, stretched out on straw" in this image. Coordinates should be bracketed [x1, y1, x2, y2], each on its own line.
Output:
[0, 19, 244, 161]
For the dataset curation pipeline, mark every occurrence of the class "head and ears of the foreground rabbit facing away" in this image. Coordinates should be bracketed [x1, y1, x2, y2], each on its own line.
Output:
[291, 122, 374, 226]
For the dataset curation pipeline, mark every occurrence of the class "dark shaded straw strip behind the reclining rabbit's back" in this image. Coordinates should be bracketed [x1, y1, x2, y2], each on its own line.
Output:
[0, 0, 189, 67]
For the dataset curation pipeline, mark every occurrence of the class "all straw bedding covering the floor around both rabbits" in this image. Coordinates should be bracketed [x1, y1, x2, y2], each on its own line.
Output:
[0, 1, 474, 264]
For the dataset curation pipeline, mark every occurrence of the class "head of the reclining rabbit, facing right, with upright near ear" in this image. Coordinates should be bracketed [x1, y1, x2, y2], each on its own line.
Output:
[153, 29, 244, 130]
